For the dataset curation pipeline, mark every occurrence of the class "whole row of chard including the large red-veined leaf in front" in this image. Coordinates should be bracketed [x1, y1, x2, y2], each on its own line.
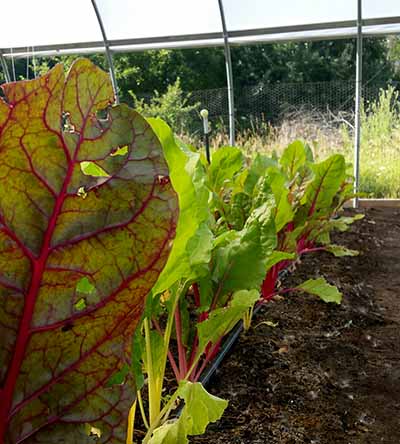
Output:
[0, 59, 358, 444]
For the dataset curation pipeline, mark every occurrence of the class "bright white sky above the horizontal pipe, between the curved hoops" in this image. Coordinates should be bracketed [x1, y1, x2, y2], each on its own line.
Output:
[0, 0, 400, 48]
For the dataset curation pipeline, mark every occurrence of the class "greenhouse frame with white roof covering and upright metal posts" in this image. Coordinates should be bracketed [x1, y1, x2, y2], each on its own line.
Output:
[0, 0, 400, 204]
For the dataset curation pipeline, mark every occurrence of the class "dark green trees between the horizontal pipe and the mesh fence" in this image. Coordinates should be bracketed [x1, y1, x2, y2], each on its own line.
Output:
[2, 37, 400, 99]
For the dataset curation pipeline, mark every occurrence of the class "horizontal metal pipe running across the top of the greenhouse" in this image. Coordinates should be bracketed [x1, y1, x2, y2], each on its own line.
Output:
[0, 15, 400, 58]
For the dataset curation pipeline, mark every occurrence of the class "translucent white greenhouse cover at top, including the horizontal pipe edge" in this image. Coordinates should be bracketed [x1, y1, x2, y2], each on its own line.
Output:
[0, 0, 400, 56]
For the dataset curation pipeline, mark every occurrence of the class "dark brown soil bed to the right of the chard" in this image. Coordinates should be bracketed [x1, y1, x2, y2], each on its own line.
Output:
[191, 209, 400, 444]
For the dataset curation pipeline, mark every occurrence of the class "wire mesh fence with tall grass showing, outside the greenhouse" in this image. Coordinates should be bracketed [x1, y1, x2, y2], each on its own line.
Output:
[137, 79, 400, 198]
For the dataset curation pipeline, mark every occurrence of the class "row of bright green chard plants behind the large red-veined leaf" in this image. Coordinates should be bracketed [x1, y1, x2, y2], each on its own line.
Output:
[126, 119, 358, 444]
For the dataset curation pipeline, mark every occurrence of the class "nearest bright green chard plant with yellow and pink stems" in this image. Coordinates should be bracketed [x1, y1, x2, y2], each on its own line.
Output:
[125, 119, 276, 444]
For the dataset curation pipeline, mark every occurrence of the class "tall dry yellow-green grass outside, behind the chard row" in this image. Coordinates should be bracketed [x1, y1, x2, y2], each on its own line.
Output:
[183, 87, 400, 198]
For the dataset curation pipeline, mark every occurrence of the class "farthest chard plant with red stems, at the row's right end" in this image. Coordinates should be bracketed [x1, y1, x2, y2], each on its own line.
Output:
[262, 141, 363, 302]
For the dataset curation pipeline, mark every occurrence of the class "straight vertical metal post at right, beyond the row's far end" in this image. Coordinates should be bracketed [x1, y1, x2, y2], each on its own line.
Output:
[353, 0, 363, 208]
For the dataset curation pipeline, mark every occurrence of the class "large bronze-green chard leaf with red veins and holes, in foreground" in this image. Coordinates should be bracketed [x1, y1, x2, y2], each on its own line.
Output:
[0, 59, 177, 444]
